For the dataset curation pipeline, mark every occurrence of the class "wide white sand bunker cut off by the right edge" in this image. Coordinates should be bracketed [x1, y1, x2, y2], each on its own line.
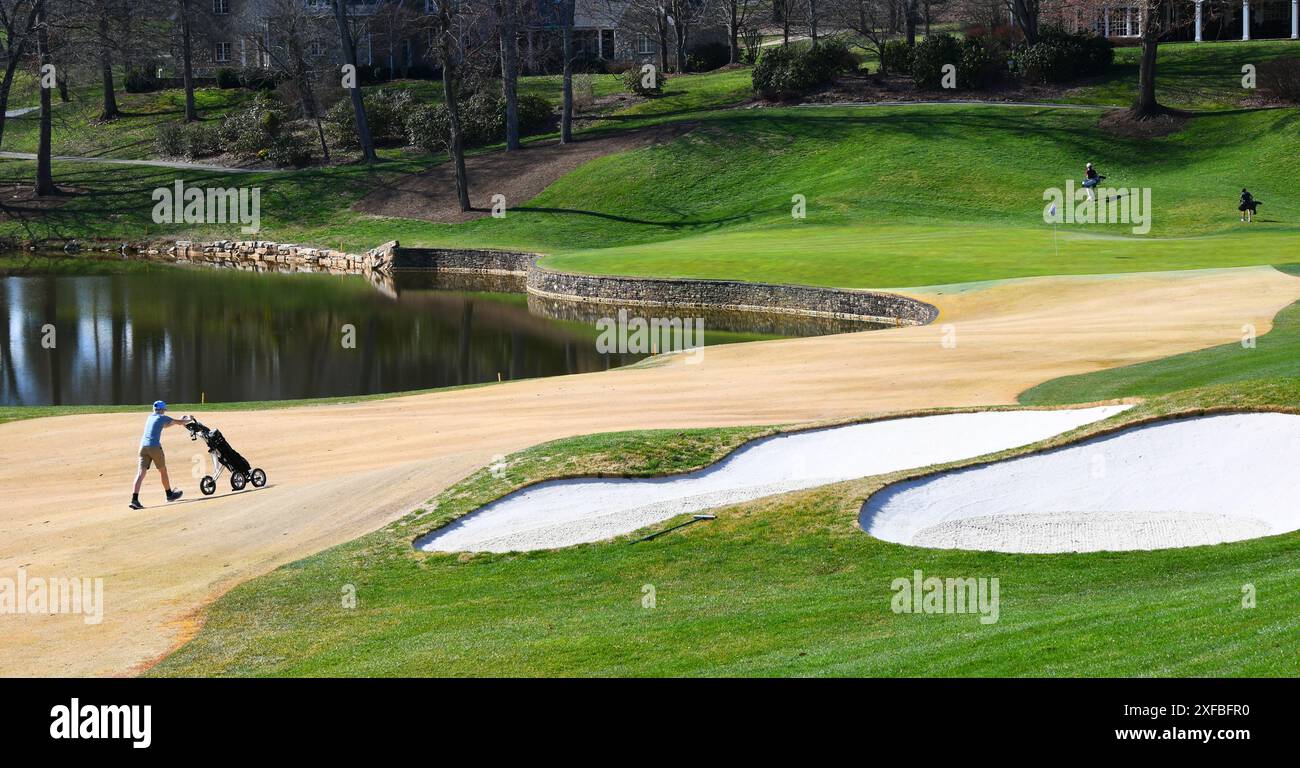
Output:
[859, 413, 1300, 552]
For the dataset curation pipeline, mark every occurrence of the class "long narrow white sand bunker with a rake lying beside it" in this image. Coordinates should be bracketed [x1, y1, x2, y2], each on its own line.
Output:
[416, 405, 1126, 552]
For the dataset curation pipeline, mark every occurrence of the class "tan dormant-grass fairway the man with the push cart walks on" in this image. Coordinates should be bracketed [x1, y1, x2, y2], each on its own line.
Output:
[0, 268, 1300, 674]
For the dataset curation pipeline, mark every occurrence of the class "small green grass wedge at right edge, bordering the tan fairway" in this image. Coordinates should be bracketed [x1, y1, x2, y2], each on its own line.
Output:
[1019, 265, 1300, 405]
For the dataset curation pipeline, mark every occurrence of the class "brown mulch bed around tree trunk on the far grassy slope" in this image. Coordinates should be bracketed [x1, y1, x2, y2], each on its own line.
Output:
[352, 122, 694, 224]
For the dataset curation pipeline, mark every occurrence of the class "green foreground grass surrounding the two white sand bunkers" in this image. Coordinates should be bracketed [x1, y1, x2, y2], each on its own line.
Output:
[152, 379, 1300, 676]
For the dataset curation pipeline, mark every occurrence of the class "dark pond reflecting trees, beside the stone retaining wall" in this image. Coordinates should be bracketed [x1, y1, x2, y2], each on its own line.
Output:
[0, 256, 883, 405]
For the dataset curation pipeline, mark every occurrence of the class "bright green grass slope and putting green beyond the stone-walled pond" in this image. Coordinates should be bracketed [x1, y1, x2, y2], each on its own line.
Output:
[10, 107, 1300, 287]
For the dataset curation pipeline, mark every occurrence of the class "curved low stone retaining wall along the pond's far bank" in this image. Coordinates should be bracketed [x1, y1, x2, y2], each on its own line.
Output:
[139, 240, 939, 325]
